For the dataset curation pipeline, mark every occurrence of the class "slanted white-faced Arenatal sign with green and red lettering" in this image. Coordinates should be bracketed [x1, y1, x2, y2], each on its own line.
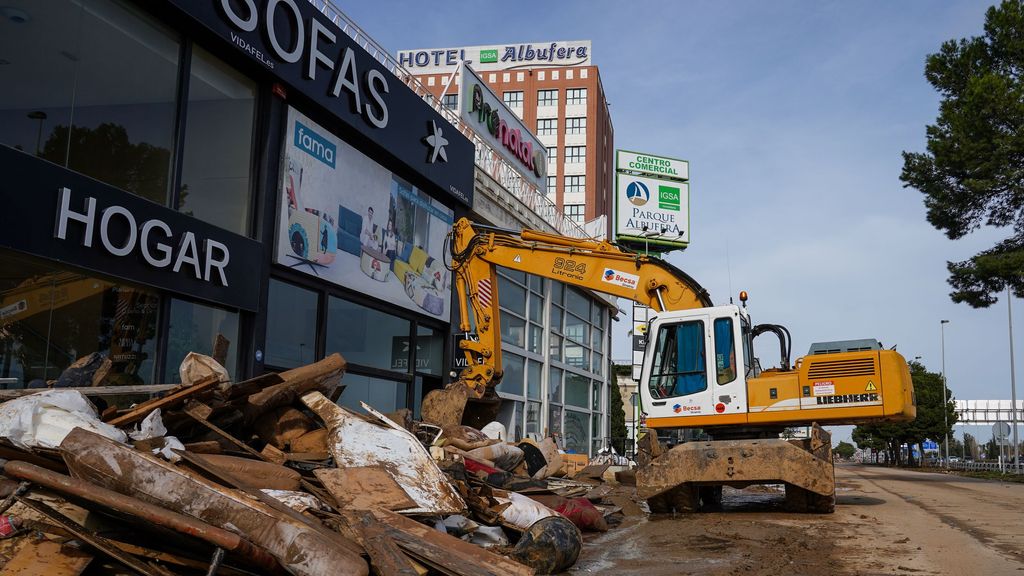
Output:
[459, 66, 548, 194]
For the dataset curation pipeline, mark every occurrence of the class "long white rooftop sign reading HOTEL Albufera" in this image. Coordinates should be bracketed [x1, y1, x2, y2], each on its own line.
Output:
[397, 40, 591, 74]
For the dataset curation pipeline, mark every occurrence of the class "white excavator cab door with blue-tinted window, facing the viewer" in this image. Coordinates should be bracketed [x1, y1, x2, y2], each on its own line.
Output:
[641, 314, 715, 425]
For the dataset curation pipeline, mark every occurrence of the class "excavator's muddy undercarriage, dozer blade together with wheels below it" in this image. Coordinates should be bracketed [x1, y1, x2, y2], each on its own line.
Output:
[637, 423, 836, 512]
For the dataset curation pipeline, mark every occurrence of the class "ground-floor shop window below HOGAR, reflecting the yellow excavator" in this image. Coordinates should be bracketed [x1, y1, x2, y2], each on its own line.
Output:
[0, 254, 160, 388]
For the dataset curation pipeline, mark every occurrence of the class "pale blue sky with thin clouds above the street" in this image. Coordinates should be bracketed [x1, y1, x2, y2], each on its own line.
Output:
[348, 0, 1024, 439]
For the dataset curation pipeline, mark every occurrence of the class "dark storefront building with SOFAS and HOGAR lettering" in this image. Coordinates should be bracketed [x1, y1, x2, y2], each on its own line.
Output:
[0, 0, 474, 411]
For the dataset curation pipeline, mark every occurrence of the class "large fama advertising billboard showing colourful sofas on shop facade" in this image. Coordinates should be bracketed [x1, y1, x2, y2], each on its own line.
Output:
[274, 109, 453, 322]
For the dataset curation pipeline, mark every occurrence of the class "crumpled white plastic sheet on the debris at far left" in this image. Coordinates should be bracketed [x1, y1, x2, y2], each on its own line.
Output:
[0, 389, 128, 449]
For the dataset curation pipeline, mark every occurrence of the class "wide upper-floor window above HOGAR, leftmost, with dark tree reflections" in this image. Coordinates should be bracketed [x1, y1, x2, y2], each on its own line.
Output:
[0, 0, 179, 206]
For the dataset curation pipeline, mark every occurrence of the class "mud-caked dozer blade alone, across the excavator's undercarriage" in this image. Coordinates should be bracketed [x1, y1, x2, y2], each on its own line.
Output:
[637, 440, 836, 500]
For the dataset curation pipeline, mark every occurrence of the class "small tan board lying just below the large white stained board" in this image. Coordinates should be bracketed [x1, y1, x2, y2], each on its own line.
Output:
[313, 466, 418, 510]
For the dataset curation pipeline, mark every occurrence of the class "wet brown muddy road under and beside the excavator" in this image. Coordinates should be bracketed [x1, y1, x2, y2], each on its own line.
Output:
[569, 465, 1024, 576]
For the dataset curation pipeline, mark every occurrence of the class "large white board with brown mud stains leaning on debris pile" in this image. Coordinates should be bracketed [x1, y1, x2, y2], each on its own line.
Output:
[302, 392, 466, 515]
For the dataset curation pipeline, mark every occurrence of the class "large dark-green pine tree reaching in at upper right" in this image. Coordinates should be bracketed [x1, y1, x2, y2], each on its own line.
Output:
[900, 0, 1024, 307]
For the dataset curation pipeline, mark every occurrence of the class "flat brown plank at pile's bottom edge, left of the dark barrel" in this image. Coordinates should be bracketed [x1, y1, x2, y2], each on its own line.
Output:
[373, 508, 535, 576]
